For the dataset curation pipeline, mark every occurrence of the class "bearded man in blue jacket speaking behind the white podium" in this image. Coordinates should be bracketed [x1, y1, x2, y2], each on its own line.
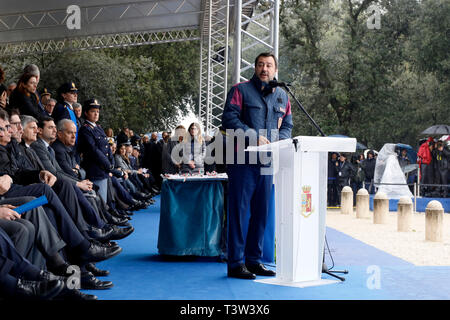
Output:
[222, 53, 293, 279]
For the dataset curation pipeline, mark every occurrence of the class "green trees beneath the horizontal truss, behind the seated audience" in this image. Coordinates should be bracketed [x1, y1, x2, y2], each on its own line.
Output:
[0, 42, 200, 133]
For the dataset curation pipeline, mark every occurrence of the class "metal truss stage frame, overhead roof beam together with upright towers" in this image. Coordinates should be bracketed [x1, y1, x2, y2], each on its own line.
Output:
[0, 0, 279, 133]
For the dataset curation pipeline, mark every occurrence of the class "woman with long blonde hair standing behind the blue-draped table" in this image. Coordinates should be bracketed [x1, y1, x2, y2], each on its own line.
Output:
[181, 122, 206, 173]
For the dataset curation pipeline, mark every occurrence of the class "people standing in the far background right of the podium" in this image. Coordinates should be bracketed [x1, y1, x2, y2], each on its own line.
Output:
[328, 137, 450, 206]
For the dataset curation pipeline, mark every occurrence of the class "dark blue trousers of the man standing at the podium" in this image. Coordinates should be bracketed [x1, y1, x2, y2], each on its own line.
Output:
[227, 165, 273, 268]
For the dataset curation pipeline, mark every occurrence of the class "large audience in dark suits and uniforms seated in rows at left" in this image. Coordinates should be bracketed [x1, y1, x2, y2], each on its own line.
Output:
[0, 65, 160, 300]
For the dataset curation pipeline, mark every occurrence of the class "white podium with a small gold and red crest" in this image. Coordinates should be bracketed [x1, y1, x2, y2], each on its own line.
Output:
[246, 136, 356, 287]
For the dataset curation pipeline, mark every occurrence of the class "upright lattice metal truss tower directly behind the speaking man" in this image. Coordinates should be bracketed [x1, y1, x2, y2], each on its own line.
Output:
[198, 0, 279, 135]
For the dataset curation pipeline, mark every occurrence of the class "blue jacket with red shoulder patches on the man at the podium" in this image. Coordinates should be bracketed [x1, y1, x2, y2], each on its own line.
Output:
[222, 75, 293, 164]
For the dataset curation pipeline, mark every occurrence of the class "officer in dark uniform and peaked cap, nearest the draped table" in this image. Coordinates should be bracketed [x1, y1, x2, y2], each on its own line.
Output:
[78, 99, 114, 202]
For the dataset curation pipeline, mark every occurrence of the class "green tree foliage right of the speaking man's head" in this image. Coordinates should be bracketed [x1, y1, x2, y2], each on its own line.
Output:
[280, 0, 450, 148]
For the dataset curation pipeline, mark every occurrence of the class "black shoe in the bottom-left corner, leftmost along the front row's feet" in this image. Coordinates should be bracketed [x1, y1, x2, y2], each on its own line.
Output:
[16, 279, 64, 300]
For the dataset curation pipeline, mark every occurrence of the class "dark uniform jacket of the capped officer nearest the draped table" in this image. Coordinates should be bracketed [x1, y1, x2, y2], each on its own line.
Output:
[77, 122, 114, 180]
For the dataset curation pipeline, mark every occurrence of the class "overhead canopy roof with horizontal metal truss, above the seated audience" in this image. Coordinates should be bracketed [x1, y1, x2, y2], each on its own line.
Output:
[0, 0, 202, 56]
